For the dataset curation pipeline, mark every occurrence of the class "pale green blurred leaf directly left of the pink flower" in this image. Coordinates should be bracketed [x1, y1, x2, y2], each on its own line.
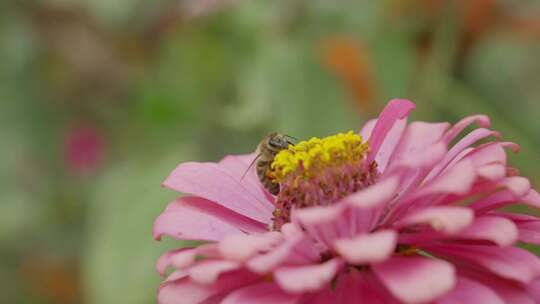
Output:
[82, 151, 183, 303]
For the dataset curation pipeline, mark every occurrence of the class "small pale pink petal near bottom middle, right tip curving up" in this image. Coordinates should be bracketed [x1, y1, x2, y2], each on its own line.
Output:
[274, 259, 341, 294]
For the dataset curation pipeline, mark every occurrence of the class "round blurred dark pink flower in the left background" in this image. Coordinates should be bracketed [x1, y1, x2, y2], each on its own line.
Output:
[64, 124, 105, 175]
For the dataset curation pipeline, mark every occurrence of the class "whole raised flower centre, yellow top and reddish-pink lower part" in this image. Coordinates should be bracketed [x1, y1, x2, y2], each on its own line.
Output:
[269, 131, 377, 230]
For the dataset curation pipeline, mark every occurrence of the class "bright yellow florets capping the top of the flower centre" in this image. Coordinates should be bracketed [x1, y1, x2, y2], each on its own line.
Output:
[271, 131, 369, 183]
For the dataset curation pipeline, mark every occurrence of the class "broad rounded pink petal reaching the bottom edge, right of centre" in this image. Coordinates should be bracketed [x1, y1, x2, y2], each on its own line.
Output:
[372, 257, 456, 303]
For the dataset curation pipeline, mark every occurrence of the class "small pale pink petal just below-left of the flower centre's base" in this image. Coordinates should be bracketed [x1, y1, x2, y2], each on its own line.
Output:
[219, 231, 283, 261]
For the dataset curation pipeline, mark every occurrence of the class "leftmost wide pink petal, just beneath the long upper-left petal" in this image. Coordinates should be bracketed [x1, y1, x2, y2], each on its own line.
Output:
[153, 197, 250, 241]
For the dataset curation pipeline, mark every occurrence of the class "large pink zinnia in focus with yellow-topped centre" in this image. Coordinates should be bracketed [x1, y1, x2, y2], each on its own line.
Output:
[154, 100, 540, 304]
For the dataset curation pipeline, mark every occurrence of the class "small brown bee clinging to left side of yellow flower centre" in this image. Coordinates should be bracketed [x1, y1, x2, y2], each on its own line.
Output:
[242, 132, 295, 195]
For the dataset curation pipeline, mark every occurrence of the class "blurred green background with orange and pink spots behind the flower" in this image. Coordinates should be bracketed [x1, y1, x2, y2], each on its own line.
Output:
[0, 0, 540, 304]
